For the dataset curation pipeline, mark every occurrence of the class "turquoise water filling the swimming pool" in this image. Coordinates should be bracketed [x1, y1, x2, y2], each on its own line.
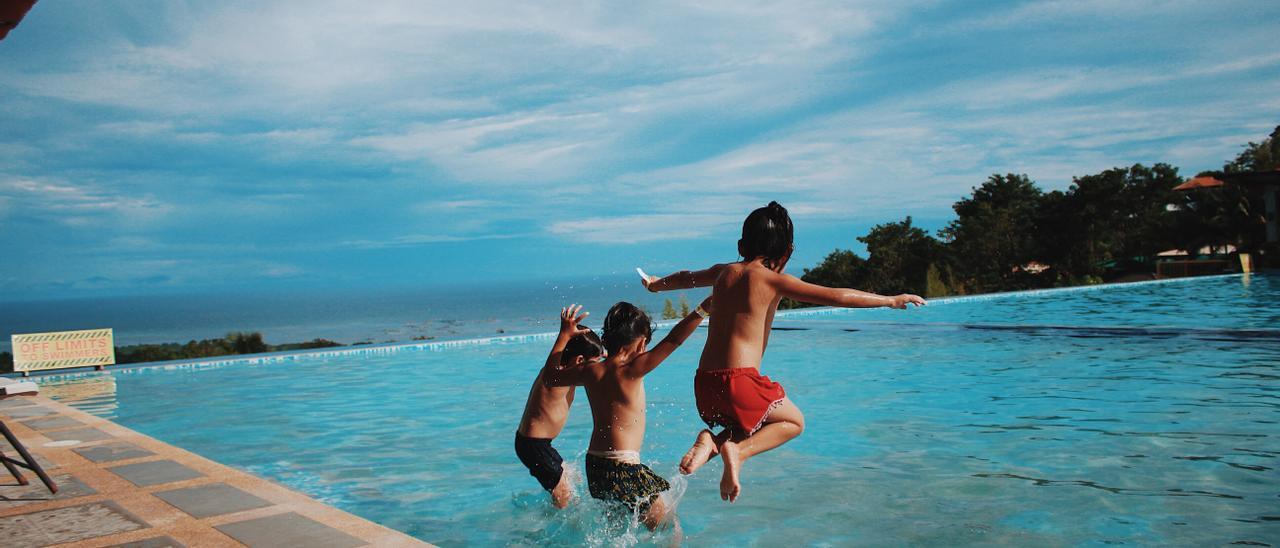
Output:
[45, 275, 1280, 545]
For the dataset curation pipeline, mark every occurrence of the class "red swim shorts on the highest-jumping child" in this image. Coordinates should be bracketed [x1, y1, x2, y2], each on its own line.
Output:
[694, 367, 787, 434]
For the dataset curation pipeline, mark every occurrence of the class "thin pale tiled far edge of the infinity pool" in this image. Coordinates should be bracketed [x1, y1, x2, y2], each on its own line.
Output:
[0, 273, 1244, 379]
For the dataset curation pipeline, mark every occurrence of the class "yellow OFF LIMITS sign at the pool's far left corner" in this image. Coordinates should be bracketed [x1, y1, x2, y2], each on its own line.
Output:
[12, 329, 115, 371]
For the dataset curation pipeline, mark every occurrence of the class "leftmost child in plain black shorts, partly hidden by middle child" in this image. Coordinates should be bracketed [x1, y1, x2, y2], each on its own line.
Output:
[516, 305, 604, 508]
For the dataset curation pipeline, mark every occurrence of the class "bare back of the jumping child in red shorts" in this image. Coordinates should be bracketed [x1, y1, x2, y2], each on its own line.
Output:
[698, 262, 782, 370]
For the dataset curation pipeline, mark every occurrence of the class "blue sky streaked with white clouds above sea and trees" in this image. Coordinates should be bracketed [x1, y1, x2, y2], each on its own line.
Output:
[0, 0, 1280, 300]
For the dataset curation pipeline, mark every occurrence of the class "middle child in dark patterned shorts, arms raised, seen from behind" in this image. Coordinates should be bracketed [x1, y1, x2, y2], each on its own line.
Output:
[543, 298, 710, 530]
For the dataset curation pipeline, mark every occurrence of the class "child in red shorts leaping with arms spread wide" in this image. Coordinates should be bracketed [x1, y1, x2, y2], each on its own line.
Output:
[643, 202, 924, 502]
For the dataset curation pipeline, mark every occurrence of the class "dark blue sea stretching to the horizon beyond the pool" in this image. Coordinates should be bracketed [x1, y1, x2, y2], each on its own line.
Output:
[0, 273, 708, 352]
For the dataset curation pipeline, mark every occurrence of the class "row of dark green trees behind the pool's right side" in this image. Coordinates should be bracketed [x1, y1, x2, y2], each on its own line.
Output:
[782, 127, 1280, 307]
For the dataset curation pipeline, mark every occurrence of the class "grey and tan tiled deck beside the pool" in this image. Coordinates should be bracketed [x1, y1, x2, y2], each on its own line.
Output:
[0, 396, 430, 548]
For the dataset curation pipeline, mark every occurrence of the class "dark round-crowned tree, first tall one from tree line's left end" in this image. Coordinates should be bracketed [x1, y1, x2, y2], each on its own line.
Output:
[940, 173, 1042, 292]
